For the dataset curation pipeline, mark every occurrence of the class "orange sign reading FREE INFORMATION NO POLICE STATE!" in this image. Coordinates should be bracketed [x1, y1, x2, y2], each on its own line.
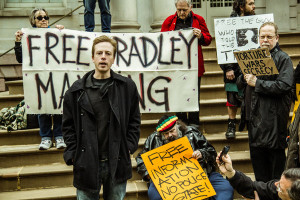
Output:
[141, 137, 216, 200]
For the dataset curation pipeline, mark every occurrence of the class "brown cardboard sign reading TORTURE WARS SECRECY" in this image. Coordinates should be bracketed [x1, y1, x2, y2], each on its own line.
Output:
[234, 49, 278, 76]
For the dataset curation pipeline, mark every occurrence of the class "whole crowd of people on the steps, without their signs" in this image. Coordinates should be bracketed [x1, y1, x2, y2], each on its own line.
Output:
[9, 0, 300, 200]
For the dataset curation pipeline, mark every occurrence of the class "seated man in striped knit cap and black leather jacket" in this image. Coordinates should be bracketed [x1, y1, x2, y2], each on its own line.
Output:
[136, 115, 233, 200]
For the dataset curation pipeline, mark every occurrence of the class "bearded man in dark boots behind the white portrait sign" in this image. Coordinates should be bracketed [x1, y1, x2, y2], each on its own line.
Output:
[220, 0, 255, 139]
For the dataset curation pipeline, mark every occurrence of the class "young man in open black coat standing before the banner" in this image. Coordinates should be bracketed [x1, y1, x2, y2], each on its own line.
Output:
[62, 36, 140, 200]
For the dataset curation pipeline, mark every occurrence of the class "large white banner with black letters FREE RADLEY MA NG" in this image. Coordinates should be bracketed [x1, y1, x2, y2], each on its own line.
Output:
[22, 28, 199, 114]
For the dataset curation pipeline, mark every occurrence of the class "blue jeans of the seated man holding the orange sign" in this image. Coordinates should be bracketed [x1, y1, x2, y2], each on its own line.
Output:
[148, 172, 233, 200]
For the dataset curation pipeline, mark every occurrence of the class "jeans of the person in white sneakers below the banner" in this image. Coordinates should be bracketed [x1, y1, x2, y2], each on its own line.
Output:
[38, 114, 62, 140]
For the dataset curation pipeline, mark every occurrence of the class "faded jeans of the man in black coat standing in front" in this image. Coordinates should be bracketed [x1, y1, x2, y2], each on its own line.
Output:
[77, 161, 127, 200]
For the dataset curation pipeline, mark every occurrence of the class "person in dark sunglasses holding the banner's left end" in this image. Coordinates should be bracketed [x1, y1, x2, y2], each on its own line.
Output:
[14, 8, 66, 150]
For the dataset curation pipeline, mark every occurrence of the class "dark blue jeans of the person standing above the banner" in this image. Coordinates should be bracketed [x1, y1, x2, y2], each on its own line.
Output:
[83, 0, 111, 33]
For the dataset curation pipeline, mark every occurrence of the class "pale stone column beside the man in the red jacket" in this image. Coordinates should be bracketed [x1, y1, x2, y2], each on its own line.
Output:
[151, 0, 176, 32]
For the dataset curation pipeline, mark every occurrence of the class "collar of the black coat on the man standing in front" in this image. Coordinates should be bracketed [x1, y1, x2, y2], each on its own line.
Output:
[69, 70, 126, 92]
